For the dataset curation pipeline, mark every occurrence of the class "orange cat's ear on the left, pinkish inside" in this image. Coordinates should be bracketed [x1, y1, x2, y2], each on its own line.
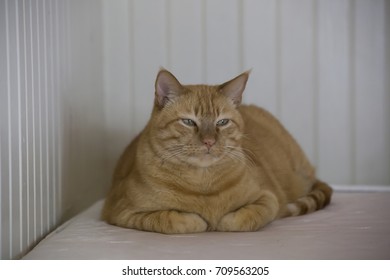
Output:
[155, 69, 183, 108]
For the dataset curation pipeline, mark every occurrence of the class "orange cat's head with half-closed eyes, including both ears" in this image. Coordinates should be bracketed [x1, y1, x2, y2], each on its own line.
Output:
[151, 69, 249, 167]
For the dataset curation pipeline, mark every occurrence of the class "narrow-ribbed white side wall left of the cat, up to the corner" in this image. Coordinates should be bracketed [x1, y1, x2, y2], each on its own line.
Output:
[0, 0, 110, 259]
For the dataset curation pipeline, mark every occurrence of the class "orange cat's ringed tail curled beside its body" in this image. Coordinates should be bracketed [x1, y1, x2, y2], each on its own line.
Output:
[281, 180, 333, 217]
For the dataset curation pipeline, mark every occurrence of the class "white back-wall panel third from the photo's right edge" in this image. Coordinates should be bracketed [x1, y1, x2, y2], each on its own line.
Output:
[280, 0, 317, 161]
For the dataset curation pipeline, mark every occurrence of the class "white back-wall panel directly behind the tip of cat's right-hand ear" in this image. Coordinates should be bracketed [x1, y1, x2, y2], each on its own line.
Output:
[242, 0, 280, 114]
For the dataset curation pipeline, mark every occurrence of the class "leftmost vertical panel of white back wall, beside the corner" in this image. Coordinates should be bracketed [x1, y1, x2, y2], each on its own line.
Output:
[103, 0, 133, 177]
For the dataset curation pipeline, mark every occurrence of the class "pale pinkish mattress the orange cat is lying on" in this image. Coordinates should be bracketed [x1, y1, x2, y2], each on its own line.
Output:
[24, 188, 390, 260]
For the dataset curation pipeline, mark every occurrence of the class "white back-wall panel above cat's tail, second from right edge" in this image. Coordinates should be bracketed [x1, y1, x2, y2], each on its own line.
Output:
[317, 0, 354, 184]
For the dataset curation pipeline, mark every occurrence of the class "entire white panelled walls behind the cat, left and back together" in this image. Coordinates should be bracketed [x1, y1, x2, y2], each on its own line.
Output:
[0, 0, 390, 259]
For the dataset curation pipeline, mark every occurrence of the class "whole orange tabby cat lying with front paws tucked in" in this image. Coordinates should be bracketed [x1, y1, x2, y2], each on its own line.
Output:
[102, 69, 332, 234]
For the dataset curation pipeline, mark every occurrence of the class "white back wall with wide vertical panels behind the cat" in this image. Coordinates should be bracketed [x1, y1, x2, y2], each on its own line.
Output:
[104, 0, 390, 185]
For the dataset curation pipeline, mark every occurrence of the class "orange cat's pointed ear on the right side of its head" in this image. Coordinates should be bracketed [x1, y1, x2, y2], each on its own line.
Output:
[219, 71, 250, 107]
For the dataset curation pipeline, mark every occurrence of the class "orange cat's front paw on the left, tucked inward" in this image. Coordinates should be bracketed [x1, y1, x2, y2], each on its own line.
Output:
[164, 211, 208, 234]
